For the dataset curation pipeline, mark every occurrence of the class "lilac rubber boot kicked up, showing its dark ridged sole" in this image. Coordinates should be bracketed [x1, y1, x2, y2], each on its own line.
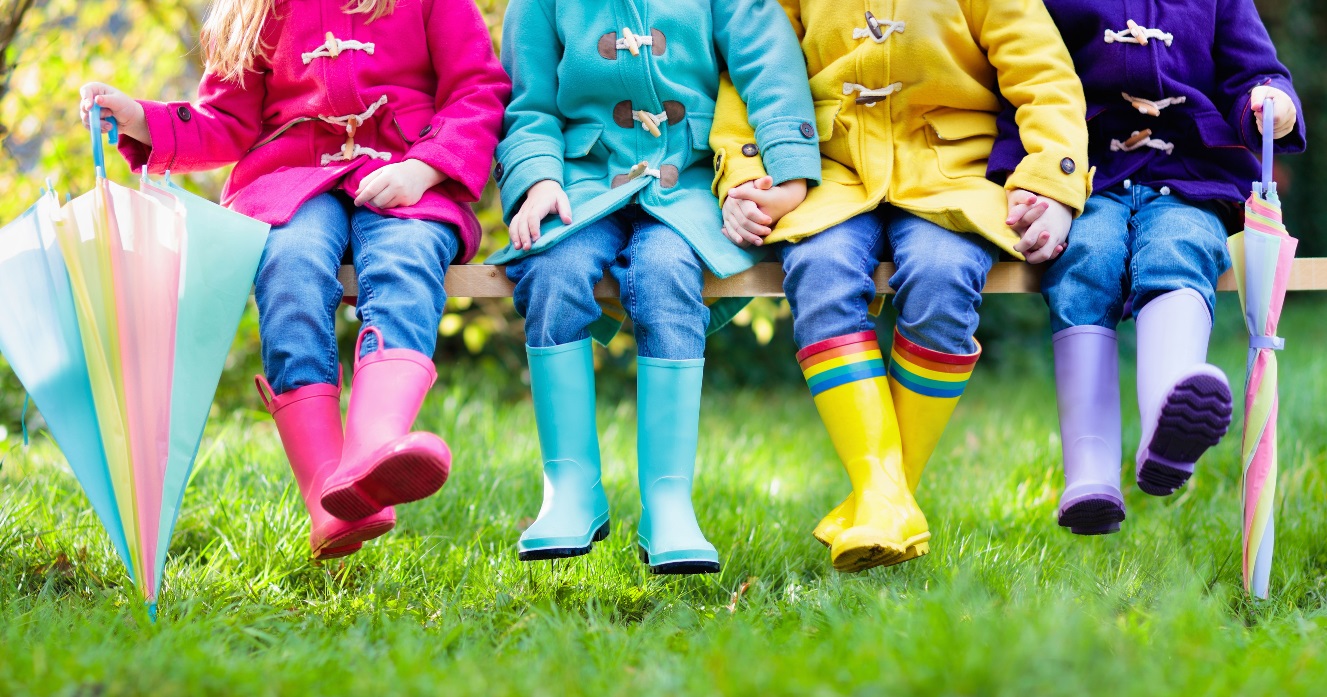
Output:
[1136, 288, 1231, 497]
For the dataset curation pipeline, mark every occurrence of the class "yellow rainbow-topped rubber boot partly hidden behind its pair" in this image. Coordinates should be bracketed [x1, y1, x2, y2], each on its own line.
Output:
[812, 331, 982, 547]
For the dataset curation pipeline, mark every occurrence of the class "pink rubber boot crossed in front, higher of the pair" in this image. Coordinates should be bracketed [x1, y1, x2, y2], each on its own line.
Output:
[322, 327, 451, 520]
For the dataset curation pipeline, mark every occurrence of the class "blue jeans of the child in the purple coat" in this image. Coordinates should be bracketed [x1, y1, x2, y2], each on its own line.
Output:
[1042, 185, 1230, 332]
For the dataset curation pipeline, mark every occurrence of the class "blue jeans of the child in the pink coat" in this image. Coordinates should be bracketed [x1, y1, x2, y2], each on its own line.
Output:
[253, 193, 460, 394]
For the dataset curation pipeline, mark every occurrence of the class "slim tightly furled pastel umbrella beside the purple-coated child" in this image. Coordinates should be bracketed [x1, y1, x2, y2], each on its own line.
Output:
[1229, 100, 1299, 599]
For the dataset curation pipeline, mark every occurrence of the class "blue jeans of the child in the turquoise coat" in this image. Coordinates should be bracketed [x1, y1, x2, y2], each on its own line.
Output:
[507, 206, 710, 361]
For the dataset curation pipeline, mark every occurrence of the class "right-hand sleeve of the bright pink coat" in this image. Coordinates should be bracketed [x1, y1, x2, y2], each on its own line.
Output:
[406, 0, 511, 202]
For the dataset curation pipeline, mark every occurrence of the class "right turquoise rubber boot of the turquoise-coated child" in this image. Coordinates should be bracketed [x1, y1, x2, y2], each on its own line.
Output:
[636, 356, 719, 574]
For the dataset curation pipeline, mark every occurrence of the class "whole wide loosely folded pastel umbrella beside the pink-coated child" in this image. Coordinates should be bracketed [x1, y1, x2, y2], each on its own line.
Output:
[0, 106, 268, 617]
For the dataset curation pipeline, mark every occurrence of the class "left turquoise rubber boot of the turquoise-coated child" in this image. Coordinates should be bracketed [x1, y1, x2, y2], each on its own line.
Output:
[516, 339, 608, 562]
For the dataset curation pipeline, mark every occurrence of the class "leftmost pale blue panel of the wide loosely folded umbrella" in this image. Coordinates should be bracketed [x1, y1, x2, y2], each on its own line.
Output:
[0, 189, 133, 575]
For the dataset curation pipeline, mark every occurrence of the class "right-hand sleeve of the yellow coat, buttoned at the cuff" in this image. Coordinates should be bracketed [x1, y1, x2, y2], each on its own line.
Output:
[967, 0, 1092, 212]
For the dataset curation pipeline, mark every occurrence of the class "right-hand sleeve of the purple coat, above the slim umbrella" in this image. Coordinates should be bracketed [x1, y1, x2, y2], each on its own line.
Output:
[1212, 0, 1306, 153]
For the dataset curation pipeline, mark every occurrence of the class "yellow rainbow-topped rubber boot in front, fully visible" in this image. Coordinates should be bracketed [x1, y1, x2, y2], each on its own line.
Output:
[798, 332, 930, 571]
